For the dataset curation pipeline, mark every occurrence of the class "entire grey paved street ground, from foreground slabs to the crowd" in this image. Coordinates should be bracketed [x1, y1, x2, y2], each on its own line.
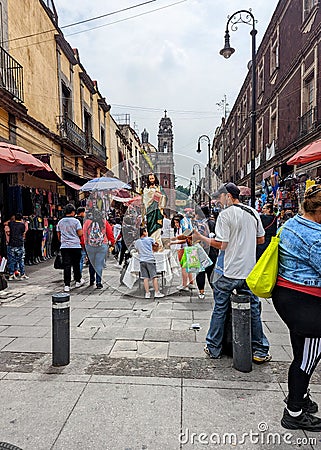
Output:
[0, 260, 321, 450]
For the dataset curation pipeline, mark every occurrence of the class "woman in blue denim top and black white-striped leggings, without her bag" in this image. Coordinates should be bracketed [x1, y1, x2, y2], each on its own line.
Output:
[272, 184, 321, 432]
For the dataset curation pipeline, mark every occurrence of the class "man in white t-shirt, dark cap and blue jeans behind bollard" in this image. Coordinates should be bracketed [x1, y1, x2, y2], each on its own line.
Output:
[193, 183, 271, 364]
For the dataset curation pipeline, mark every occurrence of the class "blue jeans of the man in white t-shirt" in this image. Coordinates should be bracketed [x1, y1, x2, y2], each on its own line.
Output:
[206, 273, 269, 357]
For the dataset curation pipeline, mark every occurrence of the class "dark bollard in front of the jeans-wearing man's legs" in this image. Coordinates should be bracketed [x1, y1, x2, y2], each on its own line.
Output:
[231, 294, 252, 372]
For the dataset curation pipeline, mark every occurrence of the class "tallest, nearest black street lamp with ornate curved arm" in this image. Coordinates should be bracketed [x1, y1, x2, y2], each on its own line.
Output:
[220, 9, 257, 208]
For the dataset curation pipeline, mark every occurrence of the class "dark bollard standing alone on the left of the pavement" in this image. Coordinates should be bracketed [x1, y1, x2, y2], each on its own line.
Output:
[52, 293, 70, 367]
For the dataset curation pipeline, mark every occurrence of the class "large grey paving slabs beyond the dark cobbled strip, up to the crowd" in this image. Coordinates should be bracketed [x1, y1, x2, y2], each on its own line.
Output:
[0, 258, 291, 362]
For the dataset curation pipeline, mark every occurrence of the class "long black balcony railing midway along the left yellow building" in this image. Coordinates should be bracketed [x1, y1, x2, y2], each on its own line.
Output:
[59, 116, 106, 163]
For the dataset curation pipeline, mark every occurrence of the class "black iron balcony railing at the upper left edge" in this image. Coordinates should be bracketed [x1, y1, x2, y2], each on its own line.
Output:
[0, 47, 23, 103]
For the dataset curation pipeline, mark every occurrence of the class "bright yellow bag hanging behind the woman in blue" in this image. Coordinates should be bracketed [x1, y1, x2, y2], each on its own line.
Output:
[246, 229, 281, 298]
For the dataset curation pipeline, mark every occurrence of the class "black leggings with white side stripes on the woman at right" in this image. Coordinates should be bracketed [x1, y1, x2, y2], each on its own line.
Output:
[272, 286, 321, 411]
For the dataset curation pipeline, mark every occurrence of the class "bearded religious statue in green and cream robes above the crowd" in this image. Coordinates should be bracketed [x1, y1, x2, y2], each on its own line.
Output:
[143, 173, 166, 250]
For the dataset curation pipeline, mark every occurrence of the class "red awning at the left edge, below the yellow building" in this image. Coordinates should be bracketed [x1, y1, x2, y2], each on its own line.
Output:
[0, 142, 52, 173]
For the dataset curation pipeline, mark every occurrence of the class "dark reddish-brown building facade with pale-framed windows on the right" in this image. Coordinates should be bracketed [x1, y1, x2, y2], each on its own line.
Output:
[213, 0, 321, 188]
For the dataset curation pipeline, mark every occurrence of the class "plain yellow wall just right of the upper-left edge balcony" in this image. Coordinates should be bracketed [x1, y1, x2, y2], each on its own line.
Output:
[8, 0, 59, 133]
